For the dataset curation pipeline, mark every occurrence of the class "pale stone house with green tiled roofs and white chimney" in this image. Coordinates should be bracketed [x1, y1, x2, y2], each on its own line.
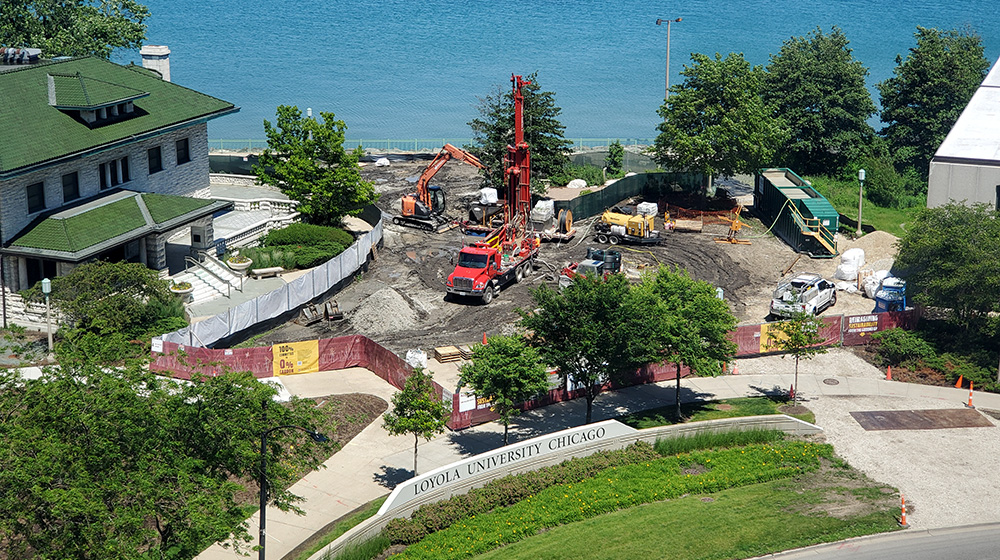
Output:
[0, 47, 239, 290]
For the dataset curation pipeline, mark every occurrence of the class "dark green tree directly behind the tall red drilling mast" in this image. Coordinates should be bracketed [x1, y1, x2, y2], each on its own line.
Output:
[465, 72, 571, 192]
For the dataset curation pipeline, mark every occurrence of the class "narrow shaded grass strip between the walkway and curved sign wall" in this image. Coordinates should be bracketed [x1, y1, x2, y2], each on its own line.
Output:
[618, 397, 816, 430]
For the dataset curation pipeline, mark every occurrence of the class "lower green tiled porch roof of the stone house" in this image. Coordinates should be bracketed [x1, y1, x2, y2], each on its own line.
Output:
[8, 191, 232, 260]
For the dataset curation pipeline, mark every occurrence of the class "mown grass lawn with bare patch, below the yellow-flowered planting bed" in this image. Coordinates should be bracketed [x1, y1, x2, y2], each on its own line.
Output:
[477, 471, 898, 560]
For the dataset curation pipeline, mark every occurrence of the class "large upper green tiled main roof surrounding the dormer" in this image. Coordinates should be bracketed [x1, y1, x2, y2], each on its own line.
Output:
[0, 58, 239, 175]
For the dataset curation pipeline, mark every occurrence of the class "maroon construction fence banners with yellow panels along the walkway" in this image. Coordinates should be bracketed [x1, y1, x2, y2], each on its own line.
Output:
[150, 309, 920, 430]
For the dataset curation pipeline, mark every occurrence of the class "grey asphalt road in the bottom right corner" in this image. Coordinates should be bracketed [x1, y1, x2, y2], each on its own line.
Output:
[762, 523, 1000, 560]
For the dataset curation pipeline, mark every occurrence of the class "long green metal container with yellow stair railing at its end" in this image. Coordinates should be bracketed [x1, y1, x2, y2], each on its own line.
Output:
[753, 168, 840, 258]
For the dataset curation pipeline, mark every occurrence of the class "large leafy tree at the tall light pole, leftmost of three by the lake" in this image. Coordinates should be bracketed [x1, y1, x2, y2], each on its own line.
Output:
[652, 53, 788, 184]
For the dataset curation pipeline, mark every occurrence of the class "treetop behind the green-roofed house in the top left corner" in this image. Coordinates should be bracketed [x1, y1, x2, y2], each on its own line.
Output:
[0, 0, 149, 58]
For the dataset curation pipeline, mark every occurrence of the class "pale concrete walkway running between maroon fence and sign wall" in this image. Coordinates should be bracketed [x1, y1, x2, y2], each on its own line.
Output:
[198, 350, 1000, 560]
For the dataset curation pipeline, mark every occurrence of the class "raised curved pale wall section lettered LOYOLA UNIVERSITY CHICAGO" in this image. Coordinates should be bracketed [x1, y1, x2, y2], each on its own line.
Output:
[378, 420, 636, 515]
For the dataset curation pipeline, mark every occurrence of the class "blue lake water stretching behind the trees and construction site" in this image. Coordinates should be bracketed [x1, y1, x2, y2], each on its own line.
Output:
[115, 0, 1000, 140]
